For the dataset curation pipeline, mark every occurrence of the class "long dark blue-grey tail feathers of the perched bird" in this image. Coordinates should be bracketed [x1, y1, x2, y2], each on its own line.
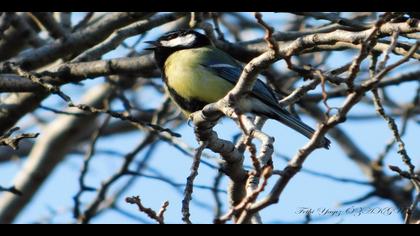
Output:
[267, 108, 331, 149]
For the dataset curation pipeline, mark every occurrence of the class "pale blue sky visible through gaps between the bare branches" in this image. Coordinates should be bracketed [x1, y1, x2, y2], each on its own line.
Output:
[0, 14, 420, 224]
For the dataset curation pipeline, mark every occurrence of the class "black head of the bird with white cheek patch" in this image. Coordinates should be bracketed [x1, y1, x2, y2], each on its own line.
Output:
[145, 29, 211, 69]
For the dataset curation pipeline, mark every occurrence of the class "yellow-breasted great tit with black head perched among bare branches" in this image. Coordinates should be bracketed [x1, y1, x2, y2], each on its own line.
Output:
[146, 29, 331, 149]
